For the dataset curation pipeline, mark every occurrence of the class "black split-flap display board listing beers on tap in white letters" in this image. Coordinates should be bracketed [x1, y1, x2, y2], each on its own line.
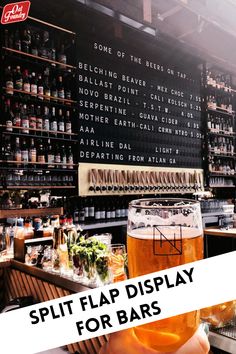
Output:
[77, 19, 202, 168]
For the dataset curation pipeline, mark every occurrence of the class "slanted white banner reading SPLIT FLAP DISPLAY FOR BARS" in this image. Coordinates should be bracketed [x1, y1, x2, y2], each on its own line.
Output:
[0, 252, 236, 354]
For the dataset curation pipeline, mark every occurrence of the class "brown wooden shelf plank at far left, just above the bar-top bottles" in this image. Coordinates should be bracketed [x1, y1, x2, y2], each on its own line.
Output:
[0, 207, 63, 219]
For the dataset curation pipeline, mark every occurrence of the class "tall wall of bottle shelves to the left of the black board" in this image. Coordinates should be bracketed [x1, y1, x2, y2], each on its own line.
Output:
[0, 22, 77, 188]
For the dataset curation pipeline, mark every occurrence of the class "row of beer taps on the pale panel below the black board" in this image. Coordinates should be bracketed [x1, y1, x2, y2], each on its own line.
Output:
[88, 169, 202, 193]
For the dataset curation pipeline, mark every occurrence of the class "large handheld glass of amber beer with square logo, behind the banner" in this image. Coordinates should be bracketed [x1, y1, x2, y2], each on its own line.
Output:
[127, 198, 203, 352]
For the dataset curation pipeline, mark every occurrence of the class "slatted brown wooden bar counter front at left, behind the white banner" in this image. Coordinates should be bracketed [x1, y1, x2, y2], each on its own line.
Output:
[0, 259, 108, 354]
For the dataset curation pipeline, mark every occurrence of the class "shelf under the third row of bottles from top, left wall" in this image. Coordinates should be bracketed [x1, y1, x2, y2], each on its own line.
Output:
[0, 124, 77, 143]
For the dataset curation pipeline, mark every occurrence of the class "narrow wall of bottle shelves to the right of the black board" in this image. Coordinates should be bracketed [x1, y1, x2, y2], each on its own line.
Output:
[204, 69, 235, 188]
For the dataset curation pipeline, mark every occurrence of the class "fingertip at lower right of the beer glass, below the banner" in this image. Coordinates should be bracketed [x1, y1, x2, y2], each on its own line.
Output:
[173, 327, 210, 354]
